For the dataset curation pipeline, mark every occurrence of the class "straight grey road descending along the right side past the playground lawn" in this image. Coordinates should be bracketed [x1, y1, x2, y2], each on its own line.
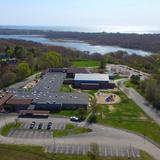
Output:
[117, 79, 160, 125]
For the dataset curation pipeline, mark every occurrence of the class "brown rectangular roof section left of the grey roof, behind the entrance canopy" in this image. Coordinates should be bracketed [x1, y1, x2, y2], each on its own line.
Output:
[7, 98, 32, 105]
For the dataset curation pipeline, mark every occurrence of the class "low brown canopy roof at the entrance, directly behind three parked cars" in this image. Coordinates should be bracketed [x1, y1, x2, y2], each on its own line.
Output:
[19, 110, 49, 116]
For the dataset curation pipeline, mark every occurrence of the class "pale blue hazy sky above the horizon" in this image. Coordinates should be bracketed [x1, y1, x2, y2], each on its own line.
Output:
[0, 0, 160, 31]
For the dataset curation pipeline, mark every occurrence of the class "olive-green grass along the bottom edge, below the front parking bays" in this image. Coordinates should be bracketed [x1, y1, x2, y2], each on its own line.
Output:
[0, 144, 153, 160]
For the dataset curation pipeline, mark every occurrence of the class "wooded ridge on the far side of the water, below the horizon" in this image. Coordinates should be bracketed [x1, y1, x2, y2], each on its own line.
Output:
[0, 29, 160, 53]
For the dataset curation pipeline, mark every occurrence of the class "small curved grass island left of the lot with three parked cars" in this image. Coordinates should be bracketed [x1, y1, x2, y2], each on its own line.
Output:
[1, 122, 21, 136]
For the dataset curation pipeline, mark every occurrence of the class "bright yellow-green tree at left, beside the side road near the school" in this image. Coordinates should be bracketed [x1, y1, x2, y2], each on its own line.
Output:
[17, 62, 31, 79]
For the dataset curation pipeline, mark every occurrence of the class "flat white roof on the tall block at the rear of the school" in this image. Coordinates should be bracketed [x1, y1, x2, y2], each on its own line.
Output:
[74, 73, 109, 81]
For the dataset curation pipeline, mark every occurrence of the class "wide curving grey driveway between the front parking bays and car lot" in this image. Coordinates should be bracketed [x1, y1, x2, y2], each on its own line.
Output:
[0, 116, 160, 160]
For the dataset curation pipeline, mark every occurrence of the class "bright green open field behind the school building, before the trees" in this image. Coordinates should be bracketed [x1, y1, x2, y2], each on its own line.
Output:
[72, 60, 100, 68]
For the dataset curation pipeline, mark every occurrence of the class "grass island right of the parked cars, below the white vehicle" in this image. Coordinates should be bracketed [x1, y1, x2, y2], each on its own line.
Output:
[53, 124, 91, 137]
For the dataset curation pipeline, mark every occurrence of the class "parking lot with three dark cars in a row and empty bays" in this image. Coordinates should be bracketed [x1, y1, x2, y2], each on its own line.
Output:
[8, 118, 67, 139]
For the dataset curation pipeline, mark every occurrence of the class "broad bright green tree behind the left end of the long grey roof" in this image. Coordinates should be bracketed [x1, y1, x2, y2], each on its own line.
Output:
[41, 52, 62, 69]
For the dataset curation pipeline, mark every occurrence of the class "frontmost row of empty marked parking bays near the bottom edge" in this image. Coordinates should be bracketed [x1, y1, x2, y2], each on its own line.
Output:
[45, 144, 140, 158]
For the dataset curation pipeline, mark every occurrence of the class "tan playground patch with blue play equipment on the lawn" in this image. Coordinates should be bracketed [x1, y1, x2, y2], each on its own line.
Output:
[96, 92, 121, 105]
